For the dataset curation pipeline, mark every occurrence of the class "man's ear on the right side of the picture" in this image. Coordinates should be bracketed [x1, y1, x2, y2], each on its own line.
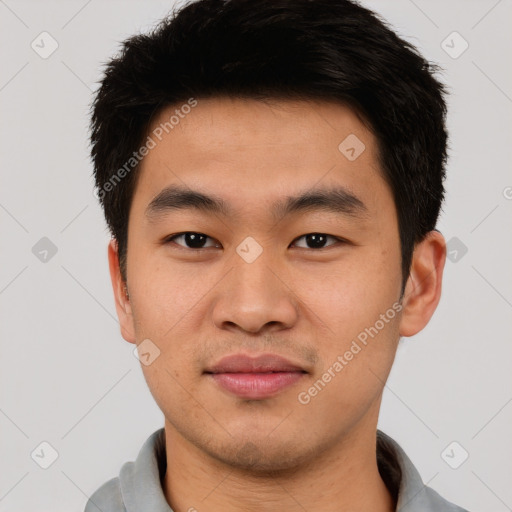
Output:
[400, 231, 446, 336]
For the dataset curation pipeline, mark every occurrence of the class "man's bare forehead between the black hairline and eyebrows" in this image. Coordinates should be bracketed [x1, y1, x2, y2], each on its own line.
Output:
[134, 97, 390, 221]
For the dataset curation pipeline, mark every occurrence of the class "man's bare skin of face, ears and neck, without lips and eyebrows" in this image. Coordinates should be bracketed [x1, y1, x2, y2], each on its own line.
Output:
[108, 98, 446, 512]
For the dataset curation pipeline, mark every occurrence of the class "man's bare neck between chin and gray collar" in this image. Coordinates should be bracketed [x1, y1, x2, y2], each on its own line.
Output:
[163, 414, 396, 512]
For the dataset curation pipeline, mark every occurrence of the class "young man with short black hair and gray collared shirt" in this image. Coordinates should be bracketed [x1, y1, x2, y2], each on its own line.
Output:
[86, 0, 468, 512]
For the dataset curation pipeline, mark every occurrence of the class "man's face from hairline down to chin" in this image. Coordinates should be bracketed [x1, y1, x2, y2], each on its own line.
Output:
[110, 98, 444, 470]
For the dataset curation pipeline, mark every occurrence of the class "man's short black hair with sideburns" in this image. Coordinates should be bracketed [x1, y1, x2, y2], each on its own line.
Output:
[91, 0, 447, 294]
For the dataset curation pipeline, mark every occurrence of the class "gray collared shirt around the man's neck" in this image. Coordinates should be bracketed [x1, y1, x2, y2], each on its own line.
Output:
[84, 428, 467, 512]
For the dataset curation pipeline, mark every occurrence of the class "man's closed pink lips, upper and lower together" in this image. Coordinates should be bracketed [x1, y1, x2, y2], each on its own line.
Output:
[205, 354, 307, 400]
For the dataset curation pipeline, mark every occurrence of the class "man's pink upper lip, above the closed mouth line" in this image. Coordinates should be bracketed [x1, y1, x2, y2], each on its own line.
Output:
[205, 353, 307, 373]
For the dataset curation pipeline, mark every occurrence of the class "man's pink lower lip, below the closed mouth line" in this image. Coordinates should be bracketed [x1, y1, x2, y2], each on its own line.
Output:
[211, 372, 305, 400]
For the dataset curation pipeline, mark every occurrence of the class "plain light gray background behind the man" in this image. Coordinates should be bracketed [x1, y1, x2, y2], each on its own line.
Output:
[0, 0, 512, 512]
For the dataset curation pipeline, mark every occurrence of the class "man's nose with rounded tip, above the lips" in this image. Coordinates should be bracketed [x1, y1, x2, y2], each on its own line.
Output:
[212, 251, 298, 334]
